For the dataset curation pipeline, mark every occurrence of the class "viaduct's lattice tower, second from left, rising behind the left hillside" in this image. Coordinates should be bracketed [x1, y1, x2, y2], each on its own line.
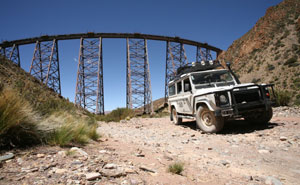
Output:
[29, 39, 61, 94]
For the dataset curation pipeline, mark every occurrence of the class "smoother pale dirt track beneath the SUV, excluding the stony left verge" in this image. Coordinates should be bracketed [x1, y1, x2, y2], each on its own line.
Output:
[99, 117, 300, 184]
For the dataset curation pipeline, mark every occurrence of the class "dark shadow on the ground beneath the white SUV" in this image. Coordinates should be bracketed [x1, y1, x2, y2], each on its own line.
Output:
[180, 120, 280, 135]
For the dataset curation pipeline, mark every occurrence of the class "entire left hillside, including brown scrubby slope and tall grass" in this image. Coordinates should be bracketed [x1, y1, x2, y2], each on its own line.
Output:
[0, 56, 98, 147]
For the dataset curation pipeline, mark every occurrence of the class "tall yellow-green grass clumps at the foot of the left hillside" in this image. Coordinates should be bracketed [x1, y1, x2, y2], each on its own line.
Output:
[0, 85, 100, 149]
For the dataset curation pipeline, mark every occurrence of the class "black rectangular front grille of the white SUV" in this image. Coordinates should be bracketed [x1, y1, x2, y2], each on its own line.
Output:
[234, 89, 261, 104]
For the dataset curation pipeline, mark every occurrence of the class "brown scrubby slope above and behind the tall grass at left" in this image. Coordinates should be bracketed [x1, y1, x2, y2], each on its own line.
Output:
[0, 57, 88, 116]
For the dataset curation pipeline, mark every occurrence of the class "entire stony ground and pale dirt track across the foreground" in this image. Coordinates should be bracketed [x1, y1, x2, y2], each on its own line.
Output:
[0, 107, 300, 185]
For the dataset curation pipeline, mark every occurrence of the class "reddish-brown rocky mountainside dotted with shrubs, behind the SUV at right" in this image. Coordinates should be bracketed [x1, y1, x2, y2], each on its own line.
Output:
[219, 0, 300, 104]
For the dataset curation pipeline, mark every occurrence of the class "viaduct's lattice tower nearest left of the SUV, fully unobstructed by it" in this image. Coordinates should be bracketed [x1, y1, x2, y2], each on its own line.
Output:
[126, 38, 153, 114]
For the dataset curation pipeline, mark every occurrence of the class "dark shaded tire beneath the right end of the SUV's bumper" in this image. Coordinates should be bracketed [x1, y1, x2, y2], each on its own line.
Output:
[244, 107, 273, 125]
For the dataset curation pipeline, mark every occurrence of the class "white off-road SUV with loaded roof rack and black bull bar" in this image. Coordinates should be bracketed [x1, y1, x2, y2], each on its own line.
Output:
[168, 61, 275, 133]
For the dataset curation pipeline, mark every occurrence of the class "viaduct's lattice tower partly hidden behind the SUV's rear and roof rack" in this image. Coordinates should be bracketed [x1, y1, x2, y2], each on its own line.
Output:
[165, 42, 188, 101]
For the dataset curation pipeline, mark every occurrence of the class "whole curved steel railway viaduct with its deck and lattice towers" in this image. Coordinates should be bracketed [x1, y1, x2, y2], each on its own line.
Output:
[0, 32, 222, 114]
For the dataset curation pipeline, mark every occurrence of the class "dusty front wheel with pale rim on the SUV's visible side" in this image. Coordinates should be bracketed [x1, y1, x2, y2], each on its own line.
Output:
[196, 106, 224, 133]
